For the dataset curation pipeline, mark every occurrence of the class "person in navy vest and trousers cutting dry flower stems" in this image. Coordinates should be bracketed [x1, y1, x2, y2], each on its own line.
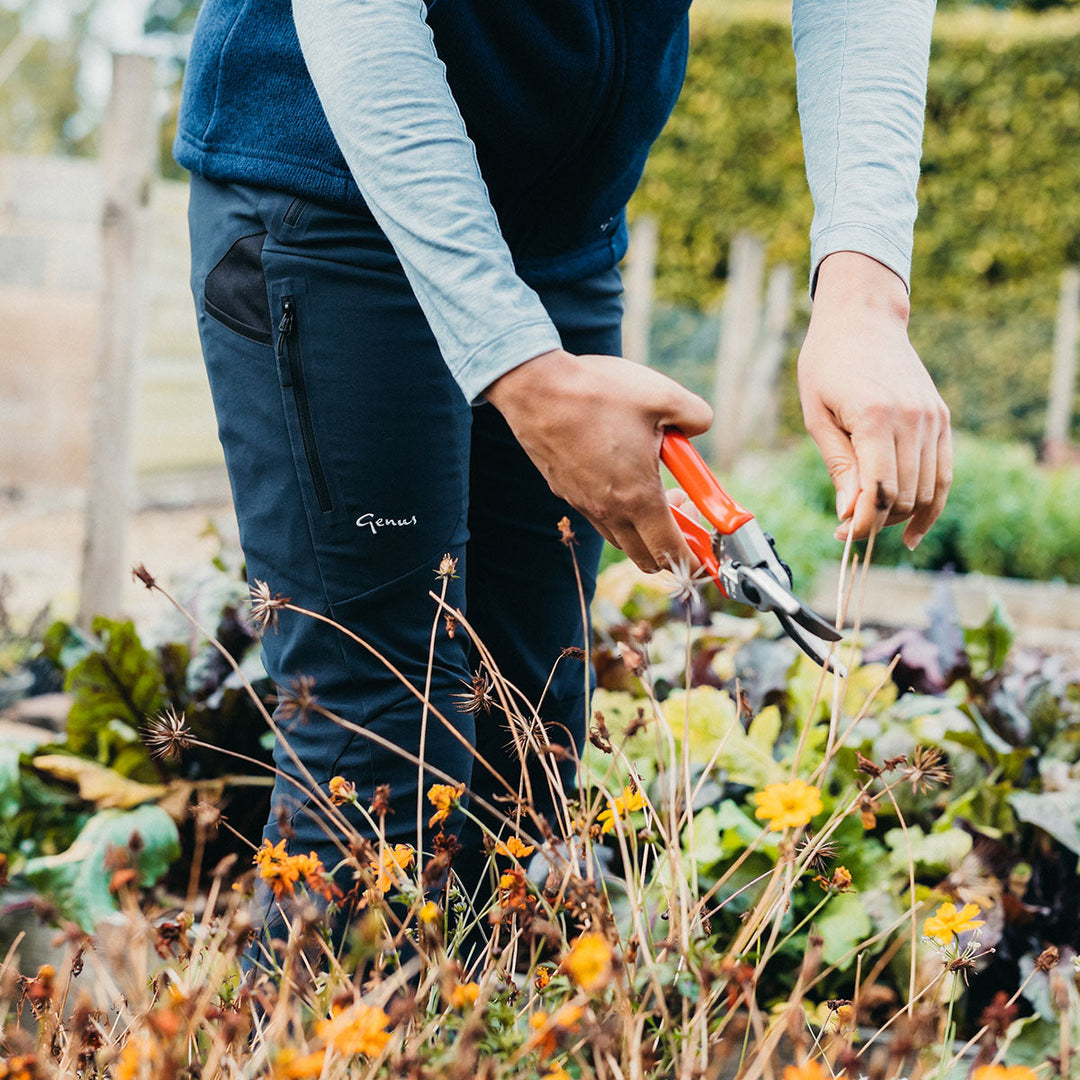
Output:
[175, 0, 951, 946]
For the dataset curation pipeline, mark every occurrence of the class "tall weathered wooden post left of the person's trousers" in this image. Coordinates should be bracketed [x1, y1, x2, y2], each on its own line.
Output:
[78, 55, 157, 626]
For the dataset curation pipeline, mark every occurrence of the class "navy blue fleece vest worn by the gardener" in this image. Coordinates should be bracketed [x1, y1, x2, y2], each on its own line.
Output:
[174, 0, 689, 284]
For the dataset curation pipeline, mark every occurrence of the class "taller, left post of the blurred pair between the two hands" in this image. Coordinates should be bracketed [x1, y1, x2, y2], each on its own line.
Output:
[713, 232, 765, 470]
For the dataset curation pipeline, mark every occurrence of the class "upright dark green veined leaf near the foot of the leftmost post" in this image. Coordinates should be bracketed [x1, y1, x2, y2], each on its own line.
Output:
[66, 617, 164, 771]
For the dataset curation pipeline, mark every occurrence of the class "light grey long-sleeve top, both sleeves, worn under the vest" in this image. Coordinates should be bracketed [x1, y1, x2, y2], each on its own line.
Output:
[293, 0, 934, 401]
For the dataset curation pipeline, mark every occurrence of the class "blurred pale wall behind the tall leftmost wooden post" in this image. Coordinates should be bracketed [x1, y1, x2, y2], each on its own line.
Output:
[0, 156, 221, 492]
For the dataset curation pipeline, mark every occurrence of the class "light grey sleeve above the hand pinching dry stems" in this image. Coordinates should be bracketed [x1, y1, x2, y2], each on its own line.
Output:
[792, 0, 934, 287]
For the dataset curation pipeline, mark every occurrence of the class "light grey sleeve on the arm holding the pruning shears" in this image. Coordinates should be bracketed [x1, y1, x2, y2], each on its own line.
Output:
[293, 0, 559, 401]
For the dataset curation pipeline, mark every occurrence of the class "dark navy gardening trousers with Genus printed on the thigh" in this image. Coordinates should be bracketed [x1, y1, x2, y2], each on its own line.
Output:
[190, 175, 622, 946]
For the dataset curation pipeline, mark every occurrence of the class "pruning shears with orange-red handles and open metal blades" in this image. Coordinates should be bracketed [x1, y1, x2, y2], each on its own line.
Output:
[660, 428, 845, 675]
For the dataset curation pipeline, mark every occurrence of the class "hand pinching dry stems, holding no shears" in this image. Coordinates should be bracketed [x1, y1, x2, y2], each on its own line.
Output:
[798, 252, 953, 551]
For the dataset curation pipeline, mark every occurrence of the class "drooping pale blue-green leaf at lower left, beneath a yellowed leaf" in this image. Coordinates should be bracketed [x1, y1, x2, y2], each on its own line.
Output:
[23, 806, 180, 933]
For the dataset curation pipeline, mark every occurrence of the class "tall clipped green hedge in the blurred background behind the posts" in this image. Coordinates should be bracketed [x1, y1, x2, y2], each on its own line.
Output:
[633, 4, 1080, 441]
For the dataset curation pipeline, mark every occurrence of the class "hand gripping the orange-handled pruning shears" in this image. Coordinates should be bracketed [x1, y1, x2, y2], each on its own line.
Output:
[485, 349, 713, 573]
